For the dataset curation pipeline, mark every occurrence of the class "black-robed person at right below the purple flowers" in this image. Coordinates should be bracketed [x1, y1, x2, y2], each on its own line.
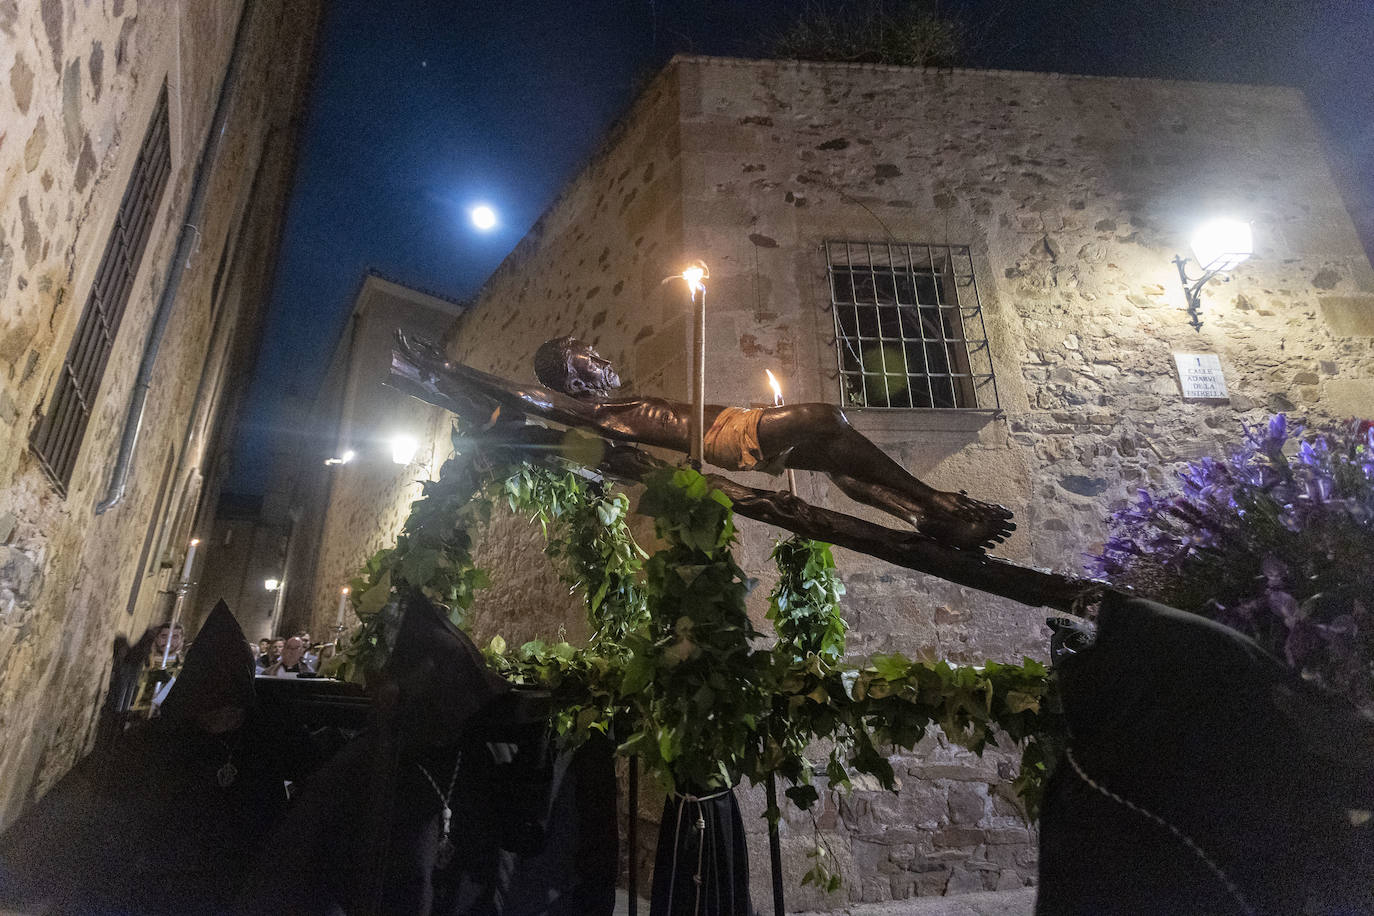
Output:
[1036, 596, 1374, 915]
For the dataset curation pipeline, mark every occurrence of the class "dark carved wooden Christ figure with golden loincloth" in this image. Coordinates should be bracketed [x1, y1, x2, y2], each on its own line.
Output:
[393, 334, 1015, 549]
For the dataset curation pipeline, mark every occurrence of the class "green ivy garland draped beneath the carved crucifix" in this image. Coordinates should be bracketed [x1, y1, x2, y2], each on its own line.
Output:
[341, 430, 1063, 886]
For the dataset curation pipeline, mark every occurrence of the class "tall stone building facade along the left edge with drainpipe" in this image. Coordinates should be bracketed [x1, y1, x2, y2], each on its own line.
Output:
[0, 0, 319, 828]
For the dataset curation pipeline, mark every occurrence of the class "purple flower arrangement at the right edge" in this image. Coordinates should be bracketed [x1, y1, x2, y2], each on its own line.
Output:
[1088, 413, 1374, 710]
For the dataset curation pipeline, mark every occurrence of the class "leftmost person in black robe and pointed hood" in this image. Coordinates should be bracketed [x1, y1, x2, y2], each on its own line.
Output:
[0, 602, 287, 913]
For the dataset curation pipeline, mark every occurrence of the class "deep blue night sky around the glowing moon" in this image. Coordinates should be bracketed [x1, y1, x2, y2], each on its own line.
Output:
[227, 0, 1374, 493]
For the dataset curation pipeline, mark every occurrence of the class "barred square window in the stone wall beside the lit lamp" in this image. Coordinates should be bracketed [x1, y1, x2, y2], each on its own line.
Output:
[824, 242, 999, 409]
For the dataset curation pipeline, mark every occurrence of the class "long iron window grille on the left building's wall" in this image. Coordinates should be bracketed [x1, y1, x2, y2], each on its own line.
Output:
[30, 85, 172, 494]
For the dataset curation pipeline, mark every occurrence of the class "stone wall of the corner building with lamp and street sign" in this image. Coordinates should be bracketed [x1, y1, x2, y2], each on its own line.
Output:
[451, 58, 1374, 909]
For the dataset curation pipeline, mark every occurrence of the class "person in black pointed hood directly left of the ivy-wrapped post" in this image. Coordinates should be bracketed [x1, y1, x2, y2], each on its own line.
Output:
[243, 593, 616, 916]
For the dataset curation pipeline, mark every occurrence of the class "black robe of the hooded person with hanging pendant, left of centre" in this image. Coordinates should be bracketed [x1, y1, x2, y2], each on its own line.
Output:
[242, 714, 618, 916]
